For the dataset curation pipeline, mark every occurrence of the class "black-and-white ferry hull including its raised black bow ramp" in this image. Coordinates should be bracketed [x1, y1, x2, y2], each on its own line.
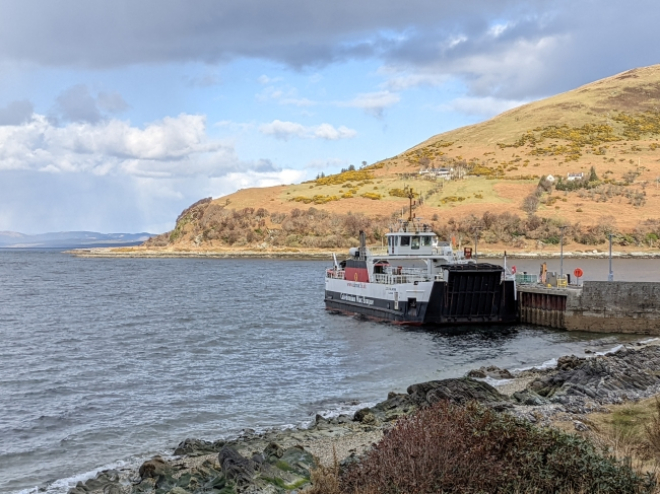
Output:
[325, 269, 517, 326]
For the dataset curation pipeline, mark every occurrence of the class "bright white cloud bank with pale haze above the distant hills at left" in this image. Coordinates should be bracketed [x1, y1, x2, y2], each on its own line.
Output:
[0, 114, 305, 232]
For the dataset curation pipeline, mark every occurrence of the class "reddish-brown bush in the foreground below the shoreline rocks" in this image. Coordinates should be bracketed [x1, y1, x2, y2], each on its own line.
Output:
[341, 402, 655, 494]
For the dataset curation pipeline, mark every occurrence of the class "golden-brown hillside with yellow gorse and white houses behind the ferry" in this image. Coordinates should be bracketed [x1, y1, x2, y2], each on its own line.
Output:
[144, 65, 660, 253]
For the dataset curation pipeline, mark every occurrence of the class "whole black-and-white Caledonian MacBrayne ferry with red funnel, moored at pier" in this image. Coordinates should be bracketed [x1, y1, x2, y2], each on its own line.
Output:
[325, 215, 517, 325]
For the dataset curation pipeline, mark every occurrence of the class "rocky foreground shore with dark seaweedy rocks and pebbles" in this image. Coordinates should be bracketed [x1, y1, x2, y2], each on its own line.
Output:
[64, 340, 660, 494]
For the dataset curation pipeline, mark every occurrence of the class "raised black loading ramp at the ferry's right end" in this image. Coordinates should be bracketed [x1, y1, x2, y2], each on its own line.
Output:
[427, 263, 517, 323]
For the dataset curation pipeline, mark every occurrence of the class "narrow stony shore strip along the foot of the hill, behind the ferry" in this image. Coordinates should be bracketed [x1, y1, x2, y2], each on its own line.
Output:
[64, 247, 660, 261]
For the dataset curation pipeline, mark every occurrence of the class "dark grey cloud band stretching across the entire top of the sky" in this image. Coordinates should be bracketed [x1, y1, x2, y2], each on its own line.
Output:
[0, 0, 660, 98]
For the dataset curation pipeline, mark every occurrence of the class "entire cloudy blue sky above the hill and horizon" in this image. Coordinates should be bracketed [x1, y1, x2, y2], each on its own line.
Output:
[0, 0, 660, 234]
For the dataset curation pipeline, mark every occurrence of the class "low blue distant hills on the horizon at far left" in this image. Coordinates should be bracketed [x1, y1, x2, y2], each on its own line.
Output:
[0, 232, 154, 249]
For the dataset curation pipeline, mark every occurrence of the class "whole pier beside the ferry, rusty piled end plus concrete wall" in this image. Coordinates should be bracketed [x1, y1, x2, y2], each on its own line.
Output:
[517, 281, 660, 335]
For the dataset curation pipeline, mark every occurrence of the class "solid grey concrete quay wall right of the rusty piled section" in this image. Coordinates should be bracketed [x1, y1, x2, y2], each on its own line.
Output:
[563, 281, 660, 335]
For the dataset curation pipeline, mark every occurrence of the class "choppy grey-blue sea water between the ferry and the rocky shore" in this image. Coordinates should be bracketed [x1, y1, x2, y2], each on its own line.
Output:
[0, 252, 654, 493]
